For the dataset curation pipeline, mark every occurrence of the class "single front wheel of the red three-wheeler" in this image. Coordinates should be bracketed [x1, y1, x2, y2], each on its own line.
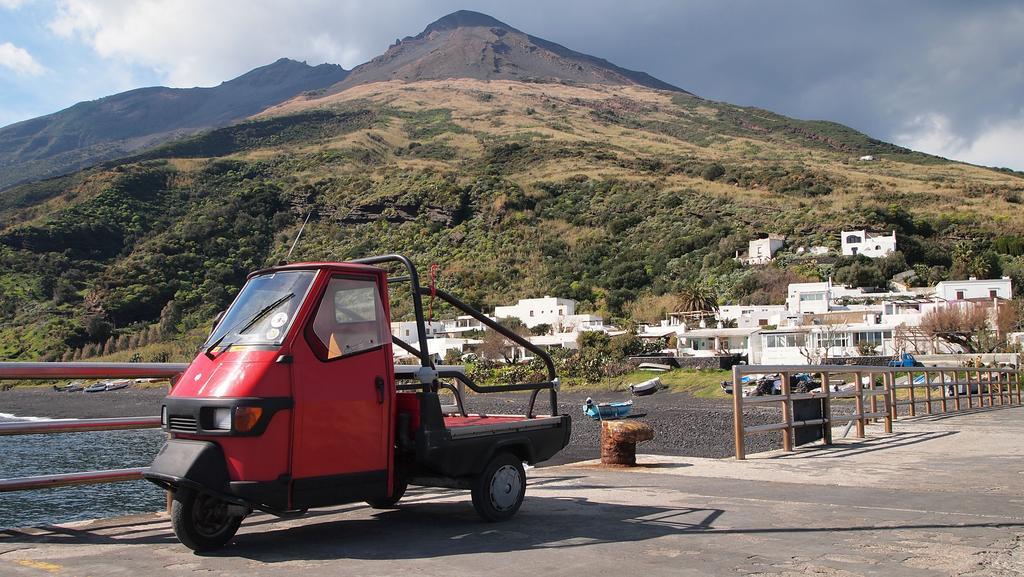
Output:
[171, 487, 244, 551]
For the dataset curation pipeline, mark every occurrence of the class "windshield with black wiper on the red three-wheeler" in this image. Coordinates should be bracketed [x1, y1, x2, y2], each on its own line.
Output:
[203, 271, 316, 346]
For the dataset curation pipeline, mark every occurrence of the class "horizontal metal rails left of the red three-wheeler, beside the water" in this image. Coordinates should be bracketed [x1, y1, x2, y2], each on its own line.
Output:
[0, 363, 188, 493]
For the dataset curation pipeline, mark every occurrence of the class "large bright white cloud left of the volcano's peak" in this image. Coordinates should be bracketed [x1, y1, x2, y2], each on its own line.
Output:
[49, 0, 415, 86]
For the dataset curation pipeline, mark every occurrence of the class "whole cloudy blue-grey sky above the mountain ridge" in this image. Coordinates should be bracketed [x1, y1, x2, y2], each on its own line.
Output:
[0, 0, 1024, 170]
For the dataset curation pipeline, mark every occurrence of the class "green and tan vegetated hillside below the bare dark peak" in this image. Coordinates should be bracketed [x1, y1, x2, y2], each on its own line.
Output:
[0, 81, 1024, 360]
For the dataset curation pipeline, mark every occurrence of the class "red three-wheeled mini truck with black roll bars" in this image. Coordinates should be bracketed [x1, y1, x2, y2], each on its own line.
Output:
[144, 255, 570, 550]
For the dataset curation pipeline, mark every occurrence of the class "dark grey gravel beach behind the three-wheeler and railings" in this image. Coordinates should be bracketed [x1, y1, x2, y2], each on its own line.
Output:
[0, 386, 780, 464]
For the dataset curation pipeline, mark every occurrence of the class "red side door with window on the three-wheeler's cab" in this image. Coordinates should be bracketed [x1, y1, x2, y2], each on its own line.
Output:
[292, 273, 394, 507]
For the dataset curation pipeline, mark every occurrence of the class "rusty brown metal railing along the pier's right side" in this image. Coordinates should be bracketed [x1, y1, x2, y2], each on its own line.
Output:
[732, 365, 1021, 460]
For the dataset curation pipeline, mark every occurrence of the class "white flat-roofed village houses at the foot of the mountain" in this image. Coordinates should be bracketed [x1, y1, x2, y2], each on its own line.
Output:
[405, 231, 1024, 368]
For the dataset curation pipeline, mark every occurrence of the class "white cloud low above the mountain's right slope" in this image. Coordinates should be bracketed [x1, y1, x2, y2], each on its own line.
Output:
[895, 113, 1024, 170]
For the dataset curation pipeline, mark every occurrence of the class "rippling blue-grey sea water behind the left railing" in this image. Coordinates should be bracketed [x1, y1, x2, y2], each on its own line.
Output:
[0, 413, 165, 530]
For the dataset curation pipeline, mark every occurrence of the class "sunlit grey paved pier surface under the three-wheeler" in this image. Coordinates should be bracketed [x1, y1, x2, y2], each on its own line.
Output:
[0, 408, 1024, 577]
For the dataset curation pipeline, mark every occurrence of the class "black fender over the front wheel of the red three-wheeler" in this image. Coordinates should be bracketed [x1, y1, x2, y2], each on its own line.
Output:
[142, 439, 237, 500]
